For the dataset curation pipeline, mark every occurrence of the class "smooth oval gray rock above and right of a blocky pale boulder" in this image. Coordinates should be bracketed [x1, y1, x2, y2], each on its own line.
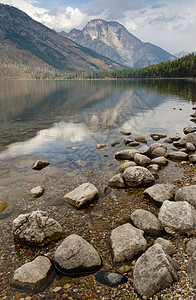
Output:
[131, 209, 164, 236]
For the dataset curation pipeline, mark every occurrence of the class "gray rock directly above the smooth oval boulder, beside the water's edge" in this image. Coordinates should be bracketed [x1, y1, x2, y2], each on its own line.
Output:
[144, 183, 177, 204]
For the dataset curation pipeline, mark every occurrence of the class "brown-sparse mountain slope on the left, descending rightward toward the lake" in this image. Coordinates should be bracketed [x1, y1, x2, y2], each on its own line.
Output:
[0, 4, 119, 78]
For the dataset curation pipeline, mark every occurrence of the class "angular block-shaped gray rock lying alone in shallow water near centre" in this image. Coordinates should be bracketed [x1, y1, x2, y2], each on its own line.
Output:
[64, 182, 99, 208]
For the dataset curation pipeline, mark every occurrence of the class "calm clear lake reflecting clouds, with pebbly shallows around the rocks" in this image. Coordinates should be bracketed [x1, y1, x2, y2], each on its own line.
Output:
[0, 80, 196, 299]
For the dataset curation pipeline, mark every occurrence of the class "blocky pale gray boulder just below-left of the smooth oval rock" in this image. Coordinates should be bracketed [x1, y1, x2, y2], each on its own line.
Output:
[110, 223, 147, 263]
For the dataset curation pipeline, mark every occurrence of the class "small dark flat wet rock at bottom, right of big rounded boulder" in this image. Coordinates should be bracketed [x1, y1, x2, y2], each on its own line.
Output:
[95, 271, 127, 287]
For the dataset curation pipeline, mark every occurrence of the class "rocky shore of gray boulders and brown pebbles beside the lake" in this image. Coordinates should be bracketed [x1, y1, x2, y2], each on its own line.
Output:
[1, 108, 196, 300]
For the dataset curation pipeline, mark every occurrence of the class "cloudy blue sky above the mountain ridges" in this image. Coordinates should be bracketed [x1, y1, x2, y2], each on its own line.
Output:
[0, 0, 196, 54]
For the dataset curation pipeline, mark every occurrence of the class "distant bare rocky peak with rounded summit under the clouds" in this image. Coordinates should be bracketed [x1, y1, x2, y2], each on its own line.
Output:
[60, 19, 176, 68]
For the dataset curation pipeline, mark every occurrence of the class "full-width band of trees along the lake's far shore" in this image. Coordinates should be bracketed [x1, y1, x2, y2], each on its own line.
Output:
[0, 53, 196, 80]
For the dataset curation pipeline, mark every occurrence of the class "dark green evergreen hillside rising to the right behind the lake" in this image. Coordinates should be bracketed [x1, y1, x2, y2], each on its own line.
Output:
[82, 53, 196, 78]
